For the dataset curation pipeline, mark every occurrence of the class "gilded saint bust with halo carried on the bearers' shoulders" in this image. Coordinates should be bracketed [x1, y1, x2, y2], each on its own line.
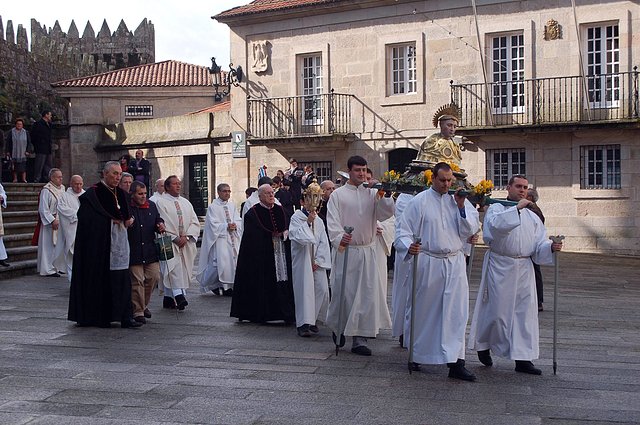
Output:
[416, 105, 462, 166]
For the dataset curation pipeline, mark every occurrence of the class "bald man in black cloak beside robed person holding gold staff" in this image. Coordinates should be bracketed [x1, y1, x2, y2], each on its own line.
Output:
[231, 184, 296, 323]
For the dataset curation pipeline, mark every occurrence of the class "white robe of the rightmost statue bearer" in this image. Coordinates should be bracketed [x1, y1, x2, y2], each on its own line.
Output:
[469, 204, 553, 360]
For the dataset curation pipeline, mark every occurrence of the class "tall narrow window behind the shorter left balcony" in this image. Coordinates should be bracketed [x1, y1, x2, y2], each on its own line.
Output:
[300, 55, 323, 125]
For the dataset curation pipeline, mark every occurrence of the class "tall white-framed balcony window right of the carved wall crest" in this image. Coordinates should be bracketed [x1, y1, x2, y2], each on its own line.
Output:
[587, 24, 620, 108]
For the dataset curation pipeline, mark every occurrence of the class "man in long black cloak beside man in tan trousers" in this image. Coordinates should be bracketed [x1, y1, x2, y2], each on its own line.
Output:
[68, 161, 142, 328]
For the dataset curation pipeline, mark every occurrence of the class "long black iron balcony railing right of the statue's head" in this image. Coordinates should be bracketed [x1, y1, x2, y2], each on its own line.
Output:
[451, 67, 640, 127]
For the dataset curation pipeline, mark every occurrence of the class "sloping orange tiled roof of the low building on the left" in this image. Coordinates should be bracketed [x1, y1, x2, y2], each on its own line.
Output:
[52, 60, 211, 88]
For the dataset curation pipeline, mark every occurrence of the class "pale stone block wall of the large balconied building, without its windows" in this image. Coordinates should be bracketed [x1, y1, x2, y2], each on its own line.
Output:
[221, 0, 640, 255]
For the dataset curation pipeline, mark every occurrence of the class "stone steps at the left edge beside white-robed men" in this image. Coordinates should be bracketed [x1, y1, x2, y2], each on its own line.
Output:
[0, 182, 44, 281]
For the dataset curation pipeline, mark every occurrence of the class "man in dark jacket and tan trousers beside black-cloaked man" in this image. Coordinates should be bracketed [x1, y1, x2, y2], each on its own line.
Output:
[128, 181, 164, 323]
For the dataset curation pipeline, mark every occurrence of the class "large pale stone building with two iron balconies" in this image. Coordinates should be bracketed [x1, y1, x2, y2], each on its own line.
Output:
[214, 0, 640, 255]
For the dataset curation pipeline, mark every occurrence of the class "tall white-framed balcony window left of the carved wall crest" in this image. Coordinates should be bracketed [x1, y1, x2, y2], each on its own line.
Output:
[491, 34, 525, 114]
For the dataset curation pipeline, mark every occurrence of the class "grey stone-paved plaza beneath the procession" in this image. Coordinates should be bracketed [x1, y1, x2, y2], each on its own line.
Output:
[0, 250, 640, 425]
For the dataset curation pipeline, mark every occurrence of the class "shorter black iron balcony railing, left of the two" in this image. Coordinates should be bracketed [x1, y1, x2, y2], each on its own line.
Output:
[247, 90, 353, 139]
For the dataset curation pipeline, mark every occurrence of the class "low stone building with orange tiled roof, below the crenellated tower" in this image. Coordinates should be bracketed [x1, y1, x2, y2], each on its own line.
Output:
[52, 60, 231, 215]
